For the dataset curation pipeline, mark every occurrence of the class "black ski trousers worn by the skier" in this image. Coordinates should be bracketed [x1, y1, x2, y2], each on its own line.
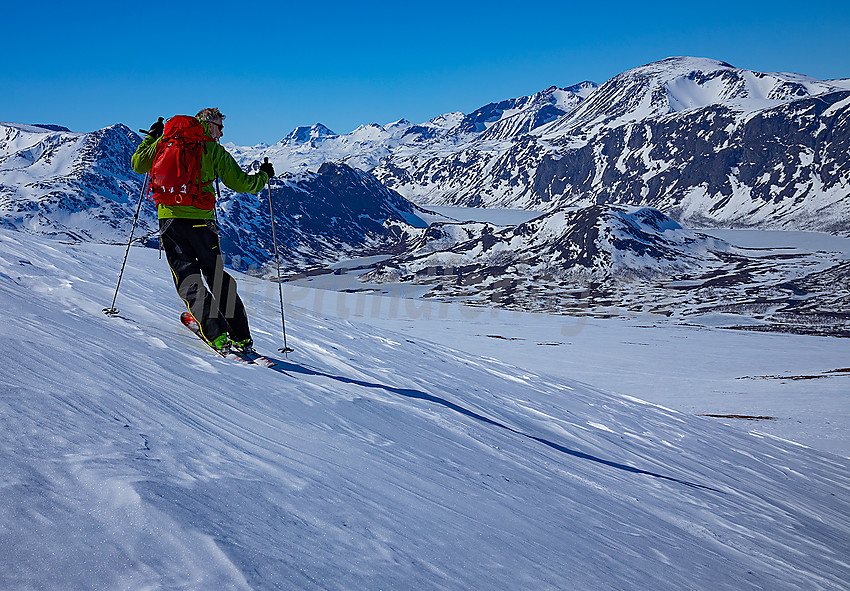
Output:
[159, 218, 251, 341]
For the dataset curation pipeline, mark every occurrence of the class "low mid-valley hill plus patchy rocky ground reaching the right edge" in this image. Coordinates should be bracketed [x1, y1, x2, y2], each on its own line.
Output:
[361, 205, 850, 335]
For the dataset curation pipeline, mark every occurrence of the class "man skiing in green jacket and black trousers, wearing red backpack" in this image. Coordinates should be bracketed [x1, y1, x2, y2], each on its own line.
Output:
[132, 108, 274, 351]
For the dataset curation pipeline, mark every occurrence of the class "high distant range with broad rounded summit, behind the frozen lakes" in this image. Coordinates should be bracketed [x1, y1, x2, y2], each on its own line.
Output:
[234, 57, 850, 235]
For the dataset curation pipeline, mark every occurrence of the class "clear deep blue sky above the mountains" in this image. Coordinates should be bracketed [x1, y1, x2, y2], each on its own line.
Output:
[6, 0, 850, 145]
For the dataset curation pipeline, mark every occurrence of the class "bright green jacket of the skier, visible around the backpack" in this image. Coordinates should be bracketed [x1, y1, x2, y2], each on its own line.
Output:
[131, 121, 269, 220]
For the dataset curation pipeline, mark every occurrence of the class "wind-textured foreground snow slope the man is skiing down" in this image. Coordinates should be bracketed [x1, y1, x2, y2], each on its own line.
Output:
[0, 230, 850, 590]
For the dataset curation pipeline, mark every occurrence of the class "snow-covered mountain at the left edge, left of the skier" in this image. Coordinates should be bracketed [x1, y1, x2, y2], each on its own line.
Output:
[0, 123, 156, 242]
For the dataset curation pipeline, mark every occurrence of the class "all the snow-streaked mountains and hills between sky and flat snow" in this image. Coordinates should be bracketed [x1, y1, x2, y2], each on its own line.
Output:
[0, 58, 850, 335]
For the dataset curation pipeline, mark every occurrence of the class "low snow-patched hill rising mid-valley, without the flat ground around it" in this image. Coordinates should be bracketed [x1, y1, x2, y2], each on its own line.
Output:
[372, 205, 730, 286]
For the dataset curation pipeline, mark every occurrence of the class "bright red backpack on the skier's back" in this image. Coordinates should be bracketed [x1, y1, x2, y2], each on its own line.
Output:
[150, 115, 215, 209]
